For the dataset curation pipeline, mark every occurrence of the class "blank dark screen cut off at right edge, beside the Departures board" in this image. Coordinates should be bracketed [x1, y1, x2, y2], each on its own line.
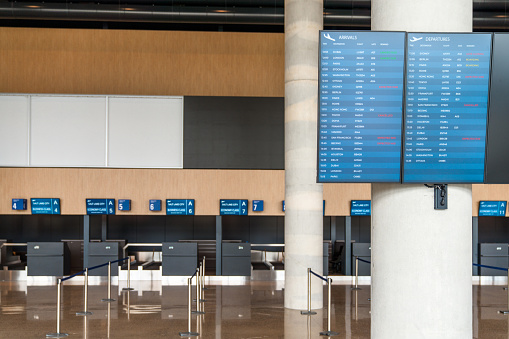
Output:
[486, 33, 509, 185]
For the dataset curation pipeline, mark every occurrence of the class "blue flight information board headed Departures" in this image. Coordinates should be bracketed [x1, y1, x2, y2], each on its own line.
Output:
[403, 33, 491, 183]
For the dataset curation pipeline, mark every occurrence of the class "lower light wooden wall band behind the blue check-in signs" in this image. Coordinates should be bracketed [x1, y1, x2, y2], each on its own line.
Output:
[0, 168, 371, 216]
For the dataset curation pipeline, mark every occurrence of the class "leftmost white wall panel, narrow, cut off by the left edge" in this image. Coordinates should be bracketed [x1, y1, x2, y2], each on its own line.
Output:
[0, 95, 29, 166]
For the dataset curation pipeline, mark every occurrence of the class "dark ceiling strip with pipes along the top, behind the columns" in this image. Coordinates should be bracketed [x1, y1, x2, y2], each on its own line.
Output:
[0, 0, 509, 30]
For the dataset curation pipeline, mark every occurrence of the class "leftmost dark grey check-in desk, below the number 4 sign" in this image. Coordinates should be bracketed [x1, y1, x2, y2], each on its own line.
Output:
[27, 242, 71, 276]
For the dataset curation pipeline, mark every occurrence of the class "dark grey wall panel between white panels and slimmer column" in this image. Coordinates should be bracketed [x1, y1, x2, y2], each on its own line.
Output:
[184, 97, 284, 169]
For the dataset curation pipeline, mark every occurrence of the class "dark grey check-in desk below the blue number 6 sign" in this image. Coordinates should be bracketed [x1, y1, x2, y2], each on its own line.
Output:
[163, 242, 198, 276]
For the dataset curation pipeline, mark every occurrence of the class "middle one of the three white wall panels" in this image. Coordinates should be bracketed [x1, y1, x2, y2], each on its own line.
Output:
[30, 96, 106, 167]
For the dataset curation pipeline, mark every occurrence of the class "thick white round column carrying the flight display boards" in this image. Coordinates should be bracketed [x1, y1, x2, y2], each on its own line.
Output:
[371, 0, 472, 339]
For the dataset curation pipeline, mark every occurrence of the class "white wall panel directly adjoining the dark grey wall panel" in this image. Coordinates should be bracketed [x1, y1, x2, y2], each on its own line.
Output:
[108, 97, 183, 168]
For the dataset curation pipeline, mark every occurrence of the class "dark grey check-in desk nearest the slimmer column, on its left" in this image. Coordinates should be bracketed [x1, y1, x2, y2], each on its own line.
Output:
[221, 243, 251, 276]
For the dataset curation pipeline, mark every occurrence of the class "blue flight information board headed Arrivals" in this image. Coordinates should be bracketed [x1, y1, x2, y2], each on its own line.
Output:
[317, 31, 405, 182]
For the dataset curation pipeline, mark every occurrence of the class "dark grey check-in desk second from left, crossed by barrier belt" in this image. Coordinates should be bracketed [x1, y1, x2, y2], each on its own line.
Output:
[88, 242, 120, 277]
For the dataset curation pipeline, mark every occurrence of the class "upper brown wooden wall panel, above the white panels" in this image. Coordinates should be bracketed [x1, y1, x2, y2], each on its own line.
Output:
[0, 27, 284, 97]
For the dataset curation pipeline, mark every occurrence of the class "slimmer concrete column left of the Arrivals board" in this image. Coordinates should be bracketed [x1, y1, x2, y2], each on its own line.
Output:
[285, 0, 323, 309]
